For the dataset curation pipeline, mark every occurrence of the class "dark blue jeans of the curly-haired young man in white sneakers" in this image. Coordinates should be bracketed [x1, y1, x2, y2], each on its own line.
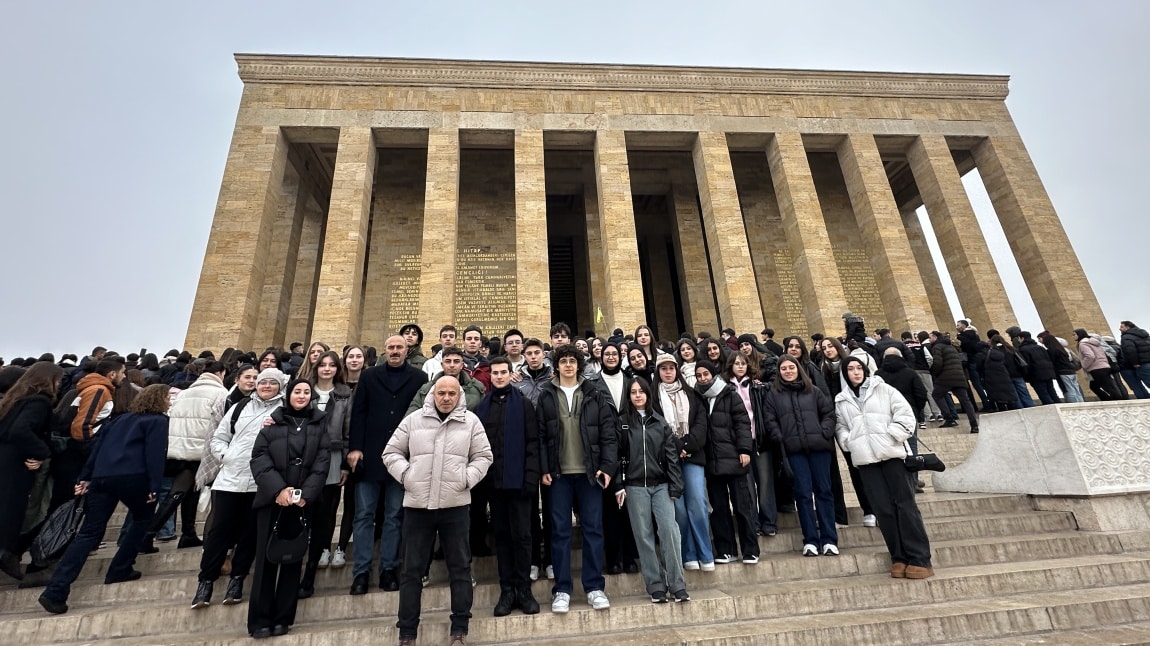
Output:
[551, 474, 606, 594]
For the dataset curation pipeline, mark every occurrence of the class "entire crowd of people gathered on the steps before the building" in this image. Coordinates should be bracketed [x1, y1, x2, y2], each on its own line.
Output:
[0, 313, 1150, 644]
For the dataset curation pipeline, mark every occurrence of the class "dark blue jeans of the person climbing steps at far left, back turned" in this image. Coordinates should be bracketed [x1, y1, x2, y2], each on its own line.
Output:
[44, 475, 155, 602]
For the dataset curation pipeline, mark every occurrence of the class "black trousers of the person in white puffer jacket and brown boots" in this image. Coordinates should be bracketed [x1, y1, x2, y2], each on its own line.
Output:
[859, 460, 930, 568]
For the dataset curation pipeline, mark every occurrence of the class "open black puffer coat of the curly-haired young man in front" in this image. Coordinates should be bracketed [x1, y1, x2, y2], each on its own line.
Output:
[536, 379, 619, 484]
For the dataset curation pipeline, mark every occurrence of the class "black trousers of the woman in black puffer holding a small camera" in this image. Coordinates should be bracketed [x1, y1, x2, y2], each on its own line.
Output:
[247, 505, 307, 633]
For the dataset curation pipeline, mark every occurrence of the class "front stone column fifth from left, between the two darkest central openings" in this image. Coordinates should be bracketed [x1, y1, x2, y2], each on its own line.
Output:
[588, 130, 646, 331]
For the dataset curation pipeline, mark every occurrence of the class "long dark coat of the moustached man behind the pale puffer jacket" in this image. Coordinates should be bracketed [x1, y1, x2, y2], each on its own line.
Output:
[347, 361, 430, 482]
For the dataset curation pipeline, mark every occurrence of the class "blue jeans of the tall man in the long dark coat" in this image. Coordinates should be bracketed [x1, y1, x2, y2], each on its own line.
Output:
[352, 476, 407, 576]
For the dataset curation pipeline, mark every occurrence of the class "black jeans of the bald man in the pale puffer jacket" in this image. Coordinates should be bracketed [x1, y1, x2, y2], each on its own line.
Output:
[396, 505, 474, 639]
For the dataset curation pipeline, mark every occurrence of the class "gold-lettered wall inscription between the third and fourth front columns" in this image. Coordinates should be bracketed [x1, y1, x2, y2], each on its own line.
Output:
[455, 247, 518, 333]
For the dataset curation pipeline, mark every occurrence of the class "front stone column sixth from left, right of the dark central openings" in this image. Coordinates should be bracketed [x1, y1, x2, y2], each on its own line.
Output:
[691, 132, 762, 334]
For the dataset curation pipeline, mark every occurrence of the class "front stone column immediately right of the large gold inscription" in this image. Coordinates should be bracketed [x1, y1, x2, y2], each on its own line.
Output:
[514, 130, 551, 330]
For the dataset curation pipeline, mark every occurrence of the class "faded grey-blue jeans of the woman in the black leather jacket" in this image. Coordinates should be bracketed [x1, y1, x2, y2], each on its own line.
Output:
[627, 484, 687, 594]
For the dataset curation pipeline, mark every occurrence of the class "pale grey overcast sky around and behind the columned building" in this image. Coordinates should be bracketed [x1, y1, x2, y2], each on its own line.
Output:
[0, 0, 1150, 359]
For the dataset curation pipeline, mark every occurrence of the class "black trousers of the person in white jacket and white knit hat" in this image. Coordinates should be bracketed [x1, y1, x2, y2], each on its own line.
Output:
[199, 491, 258, 582]
